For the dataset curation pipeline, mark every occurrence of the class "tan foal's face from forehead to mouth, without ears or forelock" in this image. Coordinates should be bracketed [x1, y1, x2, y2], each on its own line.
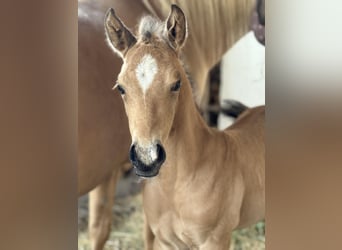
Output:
[117, 42, 182, 177]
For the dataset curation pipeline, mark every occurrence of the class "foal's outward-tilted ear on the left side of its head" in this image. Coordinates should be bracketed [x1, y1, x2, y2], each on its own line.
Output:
[104, 8, 137, 58]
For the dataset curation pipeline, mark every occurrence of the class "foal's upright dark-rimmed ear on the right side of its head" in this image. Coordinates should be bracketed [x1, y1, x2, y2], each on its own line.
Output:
[165, 4, 188, 52]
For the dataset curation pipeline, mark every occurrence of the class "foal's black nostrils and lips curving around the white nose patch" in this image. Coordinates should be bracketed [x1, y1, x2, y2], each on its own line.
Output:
[129, 144, 166, 178]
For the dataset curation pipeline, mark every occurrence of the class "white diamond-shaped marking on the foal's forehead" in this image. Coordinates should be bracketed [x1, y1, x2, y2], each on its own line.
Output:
[135, 54, 158, 93]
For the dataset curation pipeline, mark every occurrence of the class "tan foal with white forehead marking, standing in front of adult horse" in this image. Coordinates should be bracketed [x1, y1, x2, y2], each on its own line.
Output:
[105, 5, 265, 250]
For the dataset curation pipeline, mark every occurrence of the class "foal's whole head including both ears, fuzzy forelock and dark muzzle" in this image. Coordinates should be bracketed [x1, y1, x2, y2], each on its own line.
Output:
[105, 5, 187, 177]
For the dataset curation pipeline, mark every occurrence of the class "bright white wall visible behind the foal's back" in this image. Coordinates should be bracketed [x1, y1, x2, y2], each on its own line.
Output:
[218, 32, 265, 129]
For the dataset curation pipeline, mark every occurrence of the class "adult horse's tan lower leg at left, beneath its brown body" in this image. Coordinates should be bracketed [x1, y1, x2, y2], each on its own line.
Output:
[88, 168, 121, 250]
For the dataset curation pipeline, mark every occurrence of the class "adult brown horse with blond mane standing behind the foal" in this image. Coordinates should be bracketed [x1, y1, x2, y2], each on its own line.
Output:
[78, 0, 254, 249]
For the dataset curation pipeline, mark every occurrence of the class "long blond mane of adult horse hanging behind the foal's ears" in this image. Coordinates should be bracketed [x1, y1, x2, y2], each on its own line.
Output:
[143, 0, 256, 64]
